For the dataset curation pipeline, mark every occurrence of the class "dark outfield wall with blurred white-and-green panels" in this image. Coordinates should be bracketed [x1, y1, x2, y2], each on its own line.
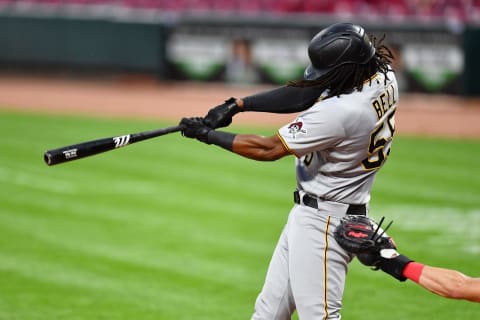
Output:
[0, 8, 480, 96]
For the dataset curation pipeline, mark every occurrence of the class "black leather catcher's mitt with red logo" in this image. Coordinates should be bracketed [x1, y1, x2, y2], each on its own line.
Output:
[334, 215, 395, 254]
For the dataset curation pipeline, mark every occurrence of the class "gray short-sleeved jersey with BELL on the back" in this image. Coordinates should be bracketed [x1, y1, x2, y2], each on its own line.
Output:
[278, 72, 399, 204]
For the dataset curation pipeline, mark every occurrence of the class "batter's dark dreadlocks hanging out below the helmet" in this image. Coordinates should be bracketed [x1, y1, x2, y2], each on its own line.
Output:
[288, 34, 393, 99]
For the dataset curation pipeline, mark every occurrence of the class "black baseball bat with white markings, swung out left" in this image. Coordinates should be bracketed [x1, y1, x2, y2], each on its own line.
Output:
[43, 125, 182, 166]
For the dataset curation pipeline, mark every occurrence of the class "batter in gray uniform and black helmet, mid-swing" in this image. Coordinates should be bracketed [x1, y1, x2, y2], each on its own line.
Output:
[180, 23, 399, 320]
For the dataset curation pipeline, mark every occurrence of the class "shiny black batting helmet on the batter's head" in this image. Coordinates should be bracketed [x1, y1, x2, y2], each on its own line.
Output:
[303, 23, 375, 80]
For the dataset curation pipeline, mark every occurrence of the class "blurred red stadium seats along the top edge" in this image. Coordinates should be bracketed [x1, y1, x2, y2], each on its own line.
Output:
[0, 0, 480, 22]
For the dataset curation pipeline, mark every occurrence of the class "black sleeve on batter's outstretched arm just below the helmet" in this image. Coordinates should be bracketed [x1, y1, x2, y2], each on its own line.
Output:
[241, 86, 321, 113]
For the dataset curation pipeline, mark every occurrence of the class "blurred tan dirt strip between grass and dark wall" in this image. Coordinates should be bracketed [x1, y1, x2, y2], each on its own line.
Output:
[0, 75, 480, 138]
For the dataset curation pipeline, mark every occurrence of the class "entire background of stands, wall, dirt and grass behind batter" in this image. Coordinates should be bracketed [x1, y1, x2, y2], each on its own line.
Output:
[0, 0, 480, 320]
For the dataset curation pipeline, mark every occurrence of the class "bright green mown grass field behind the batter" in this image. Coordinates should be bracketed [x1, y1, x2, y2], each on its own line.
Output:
[0, 112, 480, 320]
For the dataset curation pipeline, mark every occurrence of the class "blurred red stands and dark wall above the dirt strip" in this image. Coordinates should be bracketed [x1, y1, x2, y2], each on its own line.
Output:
[0, 0, 480, 95]
